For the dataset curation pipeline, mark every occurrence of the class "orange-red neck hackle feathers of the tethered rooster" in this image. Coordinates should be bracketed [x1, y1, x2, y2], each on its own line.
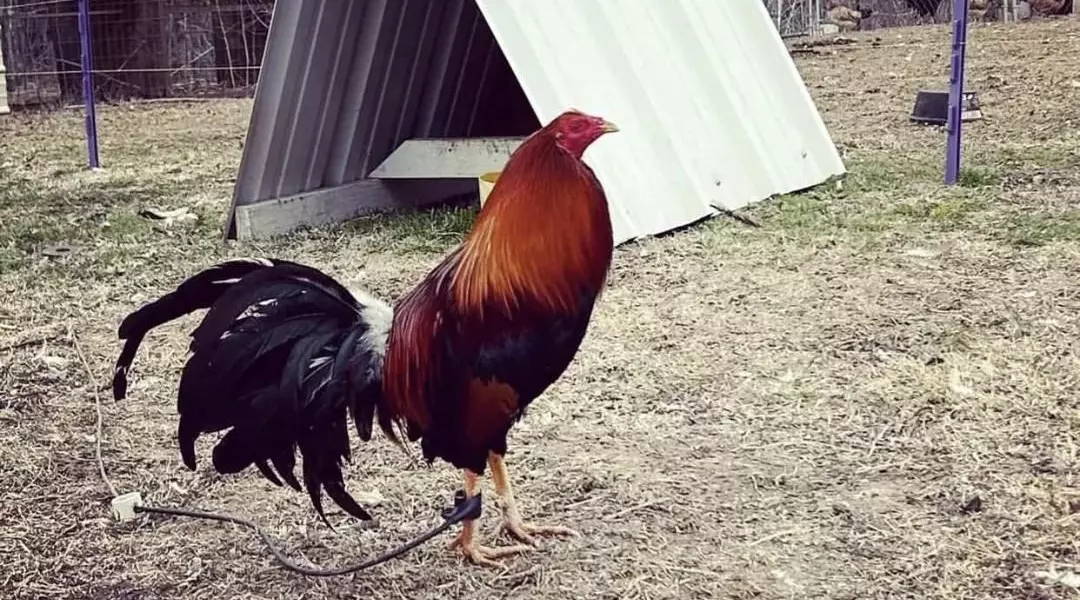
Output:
[453, 138, 613, 314]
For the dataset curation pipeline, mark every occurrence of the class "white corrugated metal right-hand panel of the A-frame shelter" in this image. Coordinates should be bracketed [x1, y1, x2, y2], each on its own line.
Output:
[476, 0, 843, 242]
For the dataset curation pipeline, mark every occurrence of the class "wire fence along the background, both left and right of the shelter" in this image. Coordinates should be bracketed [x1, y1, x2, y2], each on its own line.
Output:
[0, 0, 1074, 110]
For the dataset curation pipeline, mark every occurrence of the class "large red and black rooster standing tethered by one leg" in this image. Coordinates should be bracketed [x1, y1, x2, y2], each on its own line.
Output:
[113, 110, 618, 565]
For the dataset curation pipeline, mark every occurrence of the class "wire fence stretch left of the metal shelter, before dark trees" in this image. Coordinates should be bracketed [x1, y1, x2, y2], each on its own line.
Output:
[0, 0, 273, 107]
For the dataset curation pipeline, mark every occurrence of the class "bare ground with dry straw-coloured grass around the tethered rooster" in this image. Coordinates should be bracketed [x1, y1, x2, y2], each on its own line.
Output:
[0, 21, 1080, 600]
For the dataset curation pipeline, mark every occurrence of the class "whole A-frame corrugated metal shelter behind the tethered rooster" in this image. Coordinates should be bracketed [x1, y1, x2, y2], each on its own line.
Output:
[227, 0, 843, 243]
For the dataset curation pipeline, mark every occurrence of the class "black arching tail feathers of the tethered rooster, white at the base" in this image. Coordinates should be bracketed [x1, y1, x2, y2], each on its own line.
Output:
[112, 259, 392, 521]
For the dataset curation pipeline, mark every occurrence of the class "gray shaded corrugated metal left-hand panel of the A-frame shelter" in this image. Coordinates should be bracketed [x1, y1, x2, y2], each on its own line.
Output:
[229, 0, 538, 234]
